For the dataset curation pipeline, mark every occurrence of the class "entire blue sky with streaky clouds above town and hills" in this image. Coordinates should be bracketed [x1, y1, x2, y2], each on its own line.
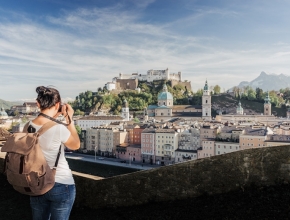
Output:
[0, 0, 290, 101]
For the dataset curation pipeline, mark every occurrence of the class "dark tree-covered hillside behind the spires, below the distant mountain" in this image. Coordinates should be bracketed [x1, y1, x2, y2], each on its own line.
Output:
[212, 93, 286, 117]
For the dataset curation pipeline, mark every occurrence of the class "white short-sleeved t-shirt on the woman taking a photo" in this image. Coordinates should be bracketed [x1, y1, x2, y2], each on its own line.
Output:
[30, 122, 74, 185]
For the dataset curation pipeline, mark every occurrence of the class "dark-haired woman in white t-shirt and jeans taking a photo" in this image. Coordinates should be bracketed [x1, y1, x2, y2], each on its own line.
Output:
[30, 86, 80, 220]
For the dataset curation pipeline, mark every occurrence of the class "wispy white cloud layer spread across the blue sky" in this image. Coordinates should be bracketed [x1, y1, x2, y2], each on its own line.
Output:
[0, 1, 290, 99]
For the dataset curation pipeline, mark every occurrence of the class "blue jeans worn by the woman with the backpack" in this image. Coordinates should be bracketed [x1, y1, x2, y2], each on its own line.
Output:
[30, 183, 76, 220]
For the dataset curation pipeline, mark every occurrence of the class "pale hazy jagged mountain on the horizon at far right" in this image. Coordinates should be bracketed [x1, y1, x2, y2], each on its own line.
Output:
[238, 72, 290, 91]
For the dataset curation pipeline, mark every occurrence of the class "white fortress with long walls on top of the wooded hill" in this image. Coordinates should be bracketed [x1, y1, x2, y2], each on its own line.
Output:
[105, 68, 191, 91]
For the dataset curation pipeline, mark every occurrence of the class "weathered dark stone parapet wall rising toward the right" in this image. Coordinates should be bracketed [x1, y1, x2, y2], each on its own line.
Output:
[0, 145, 290, 209]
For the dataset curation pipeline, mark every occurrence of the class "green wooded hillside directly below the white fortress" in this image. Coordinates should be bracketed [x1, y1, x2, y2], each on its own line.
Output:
[71, 80, 192, 115]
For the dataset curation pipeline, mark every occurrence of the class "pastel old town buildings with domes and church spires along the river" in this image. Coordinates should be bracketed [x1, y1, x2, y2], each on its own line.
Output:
[76, 81, 290, 165]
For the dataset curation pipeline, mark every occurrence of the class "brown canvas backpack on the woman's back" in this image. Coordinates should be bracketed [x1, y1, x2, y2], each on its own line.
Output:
[1, 121, 61, 196]
